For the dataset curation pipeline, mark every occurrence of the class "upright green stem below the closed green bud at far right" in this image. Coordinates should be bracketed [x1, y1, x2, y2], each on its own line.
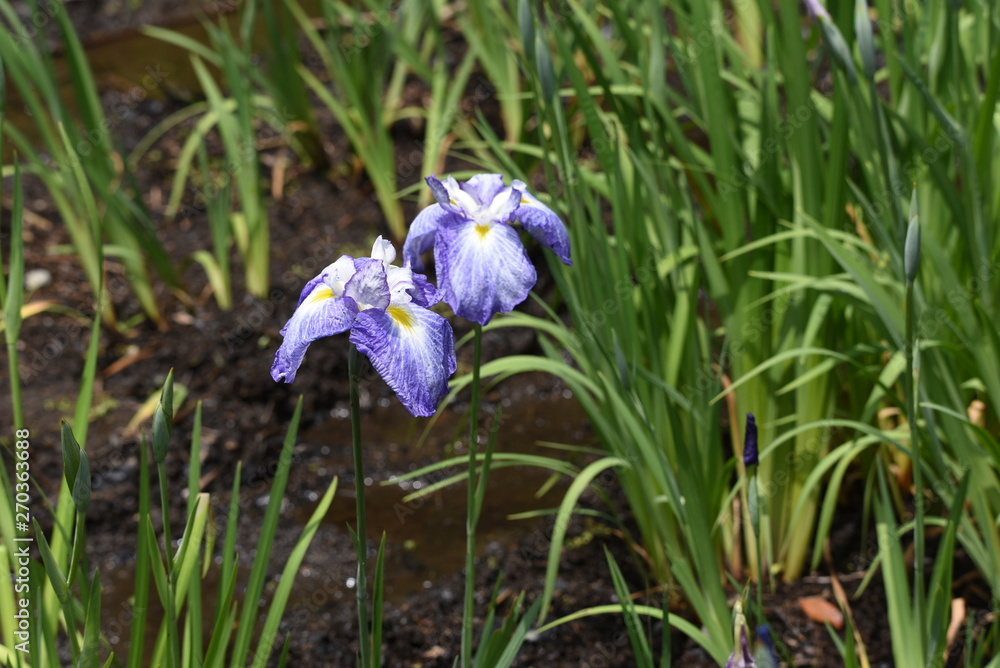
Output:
[906, 281, 924, 629]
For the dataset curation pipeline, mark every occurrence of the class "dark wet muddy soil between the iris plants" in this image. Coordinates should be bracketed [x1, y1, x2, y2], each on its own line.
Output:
[0, 0, 996, 667]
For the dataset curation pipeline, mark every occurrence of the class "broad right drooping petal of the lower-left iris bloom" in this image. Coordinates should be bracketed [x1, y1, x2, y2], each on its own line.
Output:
[351, 302, 456, 417]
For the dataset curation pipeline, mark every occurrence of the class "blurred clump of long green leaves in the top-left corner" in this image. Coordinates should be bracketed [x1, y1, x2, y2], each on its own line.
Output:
[0, 0, 177, 324]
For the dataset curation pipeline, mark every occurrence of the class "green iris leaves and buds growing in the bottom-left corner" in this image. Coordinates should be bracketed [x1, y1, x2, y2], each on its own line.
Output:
[0, 377, 337, 667]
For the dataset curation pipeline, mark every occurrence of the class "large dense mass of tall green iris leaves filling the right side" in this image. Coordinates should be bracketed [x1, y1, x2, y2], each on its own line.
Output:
[465, 0, 1000, 656]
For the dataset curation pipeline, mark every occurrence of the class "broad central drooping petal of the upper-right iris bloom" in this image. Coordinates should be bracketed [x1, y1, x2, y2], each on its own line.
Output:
[434, 223, 537, 325]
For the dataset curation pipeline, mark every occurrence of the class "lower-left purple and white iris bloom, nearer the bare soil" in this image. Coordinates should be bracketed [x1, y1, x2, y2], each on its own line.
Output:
[271, 237, 455, 417]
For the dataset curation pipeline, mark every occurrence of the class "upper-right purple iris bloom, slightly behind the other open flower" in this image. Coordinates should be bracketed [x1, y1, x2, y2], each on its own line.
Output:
[403, 174, 573, 325]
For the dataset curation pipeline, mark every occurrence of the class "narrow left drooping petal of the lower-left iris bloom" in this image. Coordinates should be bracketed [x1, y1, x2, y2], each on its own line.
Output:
[271, 290, 358, 383]
